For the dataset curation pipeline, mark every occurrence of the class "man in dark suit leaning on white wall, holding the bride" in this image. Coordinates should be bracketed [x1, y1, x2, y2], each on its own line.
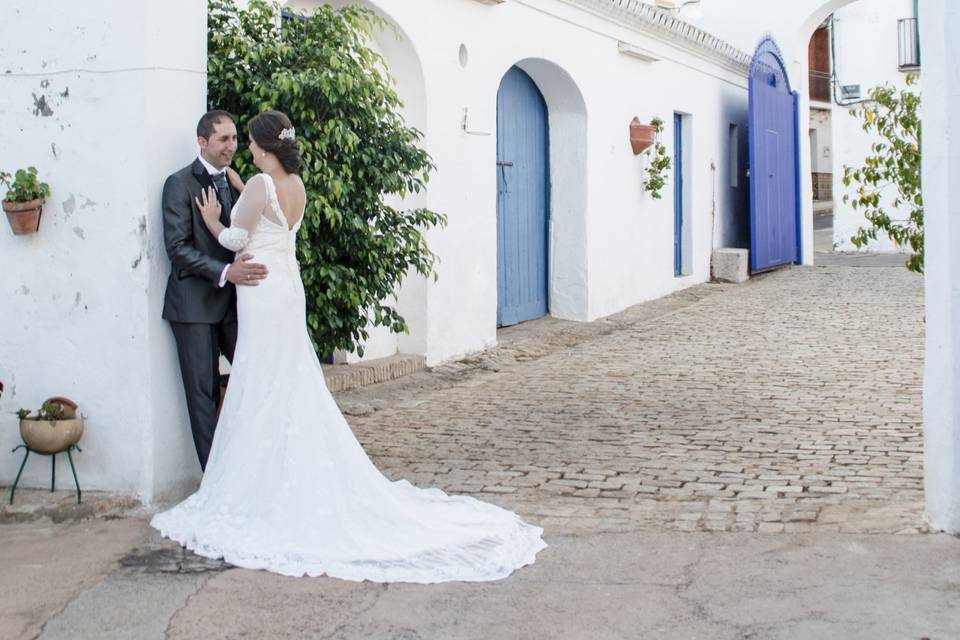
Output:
[163, 110, 267, 469]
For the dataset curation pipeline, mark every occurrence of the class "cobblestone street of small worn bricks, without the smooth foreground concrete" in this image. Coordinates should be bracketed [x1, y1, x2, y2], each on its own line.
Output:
[338, 256, 924, 535]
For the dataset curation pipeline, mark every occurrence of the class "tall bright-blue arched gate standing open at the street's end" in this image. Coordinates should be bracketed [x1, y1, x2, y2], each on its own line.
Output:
[750, 37, 800, 272]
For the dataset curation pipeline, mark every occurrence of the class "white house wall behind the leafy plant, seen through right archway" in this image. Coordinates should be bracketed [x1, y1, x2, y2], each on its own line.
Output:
[833, 0, 920, 252]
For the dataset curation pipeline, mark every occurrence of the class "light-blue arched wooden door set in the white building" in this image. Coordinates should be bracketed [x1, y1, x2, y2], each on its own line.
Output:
[497, 67, 550, 326]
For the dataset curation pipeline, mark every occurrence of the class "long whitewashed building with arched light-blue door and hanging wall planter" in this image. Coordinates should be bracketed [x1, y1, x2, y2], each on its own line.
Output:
[304, 0, 749, 364]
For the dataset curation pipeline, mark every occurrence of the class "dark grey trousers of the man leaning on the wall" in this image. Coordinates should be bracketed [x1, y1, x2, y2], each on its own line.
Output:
[170, 309, 237, 470]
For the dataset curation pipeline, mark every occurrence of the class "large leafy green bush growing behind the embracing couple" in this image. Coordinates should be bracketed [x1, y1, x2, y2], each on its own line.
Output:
[207, 0, 446, 355]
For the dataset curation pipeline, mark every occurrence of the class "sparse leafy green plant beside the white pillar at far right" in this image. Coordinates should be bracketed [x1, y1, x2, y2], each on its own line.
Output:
[843, 74, 924, 273]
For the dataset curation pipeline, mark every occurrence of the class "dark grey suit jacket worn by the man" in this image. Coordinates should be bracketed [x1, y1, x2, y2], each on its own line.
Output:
[163, 159, 239, 324]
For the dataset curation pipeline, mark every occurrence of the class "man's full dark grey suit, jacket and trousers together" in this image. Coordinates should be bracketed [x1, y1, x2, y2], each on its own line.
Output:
[163, 159, 239, 469]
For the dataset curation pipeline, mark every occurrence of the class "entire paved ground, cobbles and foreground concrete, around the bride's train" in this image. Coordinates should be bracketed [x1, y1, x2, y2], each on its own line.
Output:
[0, 255, 960, 640]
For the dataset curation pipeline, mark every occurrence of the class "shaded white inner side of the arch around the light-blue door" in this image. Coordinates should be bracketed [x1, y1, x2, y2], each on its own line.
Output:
[491, 58, 589, 320]
